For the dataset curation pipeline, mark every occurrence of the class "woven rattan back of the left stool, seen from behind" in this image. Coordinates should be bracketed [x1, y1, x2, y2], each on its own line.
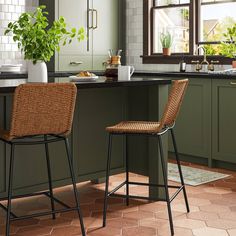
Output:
[10, 83, 77, 139]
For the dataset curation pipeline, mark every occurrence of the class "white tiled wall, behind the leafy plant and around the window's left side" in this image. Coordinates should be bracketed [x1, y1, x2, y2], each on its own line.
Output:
[0, 0, 229, 71]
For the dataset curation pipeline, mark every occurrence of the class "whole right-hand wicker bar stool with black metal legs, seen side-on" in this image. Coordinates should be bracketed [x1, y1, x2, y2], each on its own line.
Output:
[103, 79, 189, 235]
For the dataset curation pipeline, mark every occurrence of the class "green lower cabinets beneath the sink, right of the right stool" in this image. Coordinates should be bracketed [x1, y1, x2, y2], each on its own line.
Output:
[169, 78, 236, 168]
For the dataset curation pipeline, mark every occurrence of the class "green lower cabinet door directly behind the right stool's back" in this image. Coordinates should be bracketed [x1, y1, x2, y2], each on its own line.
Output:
[169, 78, 211, 161]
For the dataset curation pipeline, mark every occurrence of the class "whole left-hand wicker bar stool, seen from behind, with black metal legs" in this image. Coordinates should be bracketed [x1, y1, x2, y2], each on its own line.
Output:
[0, 83, 85, 236]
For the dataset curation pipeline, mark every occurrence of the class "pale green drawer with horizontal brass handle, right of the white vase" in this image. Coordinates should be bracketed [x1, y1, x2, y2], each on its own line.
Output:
[58, 55, 92, 71]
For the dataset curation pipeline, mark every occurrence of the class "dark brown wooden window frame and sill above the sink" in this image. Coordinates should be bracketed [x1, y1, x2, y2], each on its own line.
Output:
[141, 0, 233, 64]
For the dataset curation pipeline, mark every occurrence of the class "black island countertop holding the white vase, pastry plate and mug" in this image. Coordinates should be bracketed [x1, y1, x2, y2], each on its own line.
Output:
[0, 76, 171, 93]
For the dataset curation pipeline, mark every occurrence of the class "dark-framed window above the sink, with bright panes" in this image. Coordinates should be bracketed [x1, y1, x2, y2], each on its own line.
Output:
[143, 0, 236, 63]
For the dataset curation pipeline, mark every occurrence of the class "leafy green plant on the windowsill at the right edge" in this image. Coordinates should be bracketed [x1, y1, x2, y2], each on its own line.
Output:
[220, 23, 236, 68]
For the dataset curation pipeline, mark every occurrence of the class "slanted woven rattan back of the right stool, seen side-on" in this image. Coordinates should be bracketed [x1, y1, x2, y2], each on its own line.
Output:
[159, 79, 188, 130]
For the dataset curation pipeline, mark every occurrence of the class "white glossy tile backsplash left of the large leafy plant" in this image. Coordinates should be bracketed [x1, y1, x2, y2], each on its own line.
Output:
[0, 0, 38, 69]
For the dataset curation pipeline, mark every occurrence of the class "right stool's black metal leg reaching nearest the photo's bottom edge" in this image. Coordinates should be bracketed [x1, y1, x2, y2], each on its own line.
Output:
[157, 136, 174, 235]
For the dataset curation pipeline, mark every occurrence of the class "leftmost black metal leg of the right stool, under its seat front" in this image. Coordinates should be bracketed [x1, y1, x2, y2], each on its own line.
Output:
[103, 133, 112, 227]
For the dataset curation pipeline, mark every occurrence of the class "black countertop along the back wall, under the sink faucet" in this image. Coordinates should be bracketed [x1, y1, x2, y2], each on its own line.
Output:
[0, 71, 236, 79]
